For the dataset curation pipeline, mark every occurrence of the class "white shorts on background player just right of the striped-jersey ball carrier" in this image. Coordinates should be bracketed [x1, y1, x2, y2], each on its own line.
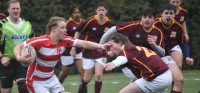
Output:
[61, 52, 82, 66]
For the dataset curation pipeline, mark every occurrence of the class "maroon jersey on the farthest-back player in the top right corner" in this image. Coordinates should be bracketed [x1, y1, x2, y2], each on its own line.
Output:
[174, 7, 188, 24]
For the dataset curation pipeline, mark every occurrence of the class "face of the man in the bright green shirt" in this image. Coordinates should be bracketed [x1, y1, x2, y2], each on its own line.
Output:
[8, 3, 21, 19]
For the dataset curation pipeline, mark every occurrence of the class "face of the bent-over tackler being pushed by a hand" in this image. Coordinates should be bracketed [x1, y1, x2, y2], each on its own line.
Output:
[107, 42, 122, 57]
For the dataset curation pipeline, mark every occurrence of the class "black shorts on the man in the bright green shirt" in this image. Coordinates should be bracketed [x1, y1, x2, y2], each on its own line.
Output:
[1, 59, 27, 88]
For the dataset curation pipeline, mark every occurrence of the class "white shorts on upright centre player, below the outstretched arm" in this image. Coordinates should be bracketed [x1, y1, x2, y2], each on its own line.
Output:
[83, 57, 107, 69]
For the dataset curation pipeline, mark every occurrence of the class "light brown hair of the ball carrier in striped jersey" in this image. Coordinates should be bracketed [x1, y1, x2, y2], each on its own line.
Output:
[46, 16, 66, 34]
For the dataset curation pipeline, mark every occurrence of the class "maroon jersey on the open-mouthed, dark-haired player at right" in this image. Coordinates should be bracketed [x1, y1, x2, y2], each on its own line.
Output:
[154, 18, 185, 55]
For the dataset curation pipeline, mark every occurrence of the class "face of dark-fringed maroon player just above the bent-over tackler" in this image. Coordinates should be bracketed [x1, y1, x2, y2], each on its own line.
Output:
[141, 16, 155, 28]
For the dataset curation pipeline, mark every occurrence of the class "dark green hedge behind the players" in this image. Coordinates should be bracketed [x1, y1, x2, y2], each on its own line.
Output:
[0, 0, 200, 69]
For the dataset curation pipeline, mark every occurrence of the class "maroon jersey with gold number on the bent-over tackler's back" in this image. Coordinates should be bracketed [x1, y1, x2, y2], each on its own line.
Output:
[120, 45, 169, 81]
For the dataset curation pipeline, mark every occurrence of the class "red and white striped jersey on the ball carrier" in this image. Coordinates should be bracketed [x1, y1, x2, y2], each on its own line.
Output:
[25, 35, 78, 81]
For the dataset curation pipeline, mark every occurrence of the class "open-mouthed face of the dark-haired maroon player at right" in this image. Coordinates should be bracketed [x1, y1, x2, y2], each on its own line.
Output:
[161, 10, 175, 24]
